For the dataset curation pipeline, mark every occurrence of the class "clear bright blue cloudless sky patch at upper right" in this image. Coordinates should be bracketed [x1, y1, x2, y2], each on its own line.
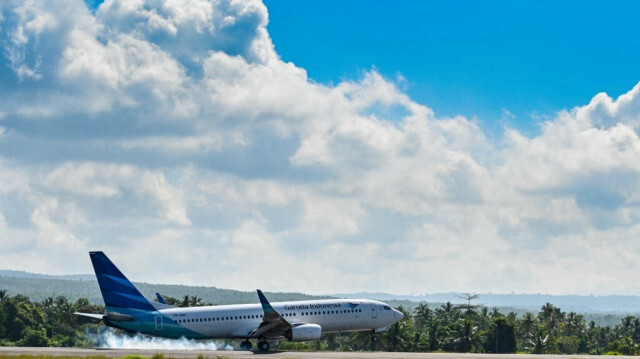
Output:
[266, 0, 640, 133]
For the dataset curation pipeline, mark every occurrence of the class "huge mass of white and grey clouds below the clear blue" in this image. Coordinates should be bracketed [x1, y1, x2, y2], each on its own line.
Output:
[0, 0, 640, 294]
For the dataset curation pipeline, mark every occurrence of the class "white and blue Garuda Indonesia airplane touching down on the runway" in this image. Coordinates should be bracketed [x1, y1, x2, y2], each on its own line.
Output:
[74, 251, 404, 352]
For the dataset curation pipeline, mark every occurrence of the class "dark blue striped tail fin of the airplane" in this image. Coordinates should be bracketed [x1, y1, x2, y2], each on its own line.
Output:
[89, 252, 155, 310]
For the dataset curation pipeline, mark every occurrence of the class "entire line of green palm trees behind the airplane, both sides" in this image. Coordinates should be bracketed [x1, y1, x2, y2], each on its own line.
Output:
[0, 290, 640, 355]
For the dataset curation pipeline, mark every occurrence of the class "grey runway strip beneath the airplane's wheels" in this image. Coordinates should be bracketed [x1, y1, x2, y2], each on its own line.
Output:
[0, 347, 636, 359]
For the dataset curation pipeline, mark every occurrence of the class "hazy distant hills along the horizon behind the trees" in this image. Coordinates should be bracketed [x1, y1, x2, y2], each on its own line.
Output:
[0, 270, 640, 325]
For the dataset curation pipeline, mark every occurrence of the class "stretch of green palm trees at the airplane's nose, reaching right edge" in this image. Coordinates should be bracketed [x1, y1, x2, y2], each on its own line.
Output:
[314, 294, 640, 355]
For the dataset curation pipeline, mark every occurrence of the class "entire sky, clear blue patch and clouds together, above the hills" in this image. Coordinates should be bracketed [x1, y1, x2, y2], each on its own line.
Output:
[0, 0, 640, 294]
